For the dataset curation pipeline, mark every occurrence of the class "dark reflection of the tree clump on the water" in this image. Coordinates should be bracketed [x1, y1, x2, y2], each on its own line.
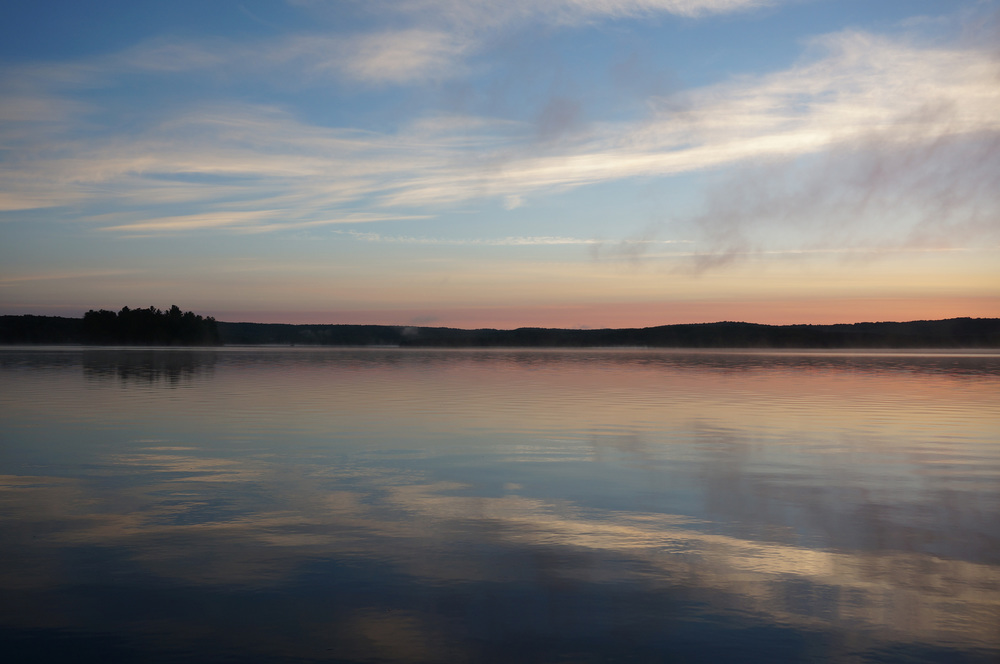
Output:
[83, 350, 218, 385]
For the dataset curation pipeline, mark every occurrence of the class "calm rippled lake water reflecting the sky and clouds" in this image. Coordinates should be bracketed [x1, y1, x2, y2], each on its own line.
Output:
[0, 349, 1000, 662]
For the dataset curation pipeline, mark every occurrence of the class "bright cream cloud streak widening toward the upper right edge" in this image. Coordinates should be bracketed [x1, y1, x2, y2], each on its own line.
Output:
[354, 32, 1000, 214]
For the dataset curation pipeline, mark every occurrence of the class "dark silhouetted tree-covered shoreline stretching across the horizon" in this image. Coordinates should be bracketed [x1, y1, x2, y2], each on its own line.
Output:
[0, 306, 1000, 349]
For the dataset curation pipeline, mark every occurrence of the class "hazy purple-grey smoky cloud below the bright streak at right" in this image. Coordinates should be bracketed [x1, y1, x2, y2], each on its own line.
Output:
[690, 128, 1000, 268]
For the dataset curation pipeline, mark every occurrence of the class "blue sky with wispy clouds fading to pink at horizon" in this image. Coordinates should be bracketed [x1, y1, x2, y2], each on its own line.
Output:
[0, 0, 1000, 328]
